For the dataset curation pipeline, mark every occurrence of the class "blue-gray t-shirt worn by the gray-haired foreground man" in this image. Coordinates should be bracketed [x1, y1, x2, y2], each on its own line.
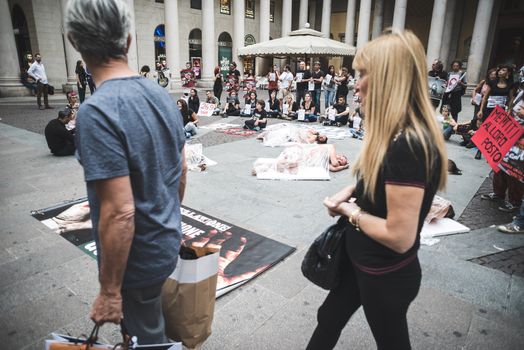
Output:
[76, 76, 185, 289]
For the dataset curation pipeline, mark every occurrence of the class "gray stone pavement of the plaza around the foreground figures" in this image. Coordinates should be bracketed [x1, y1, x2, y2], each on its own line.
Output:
[0, 96, 524, 350]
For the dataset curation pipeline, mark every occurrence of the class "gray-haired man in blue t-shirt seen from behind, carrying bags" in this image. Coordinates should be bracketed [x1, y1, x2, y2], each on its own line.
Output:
[65, 0, 187, 344]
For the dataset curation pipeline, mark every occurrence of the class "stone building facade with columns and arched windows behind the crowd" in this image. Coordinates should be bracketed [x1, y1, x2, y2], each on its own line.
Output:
[0, 0, 524, 96]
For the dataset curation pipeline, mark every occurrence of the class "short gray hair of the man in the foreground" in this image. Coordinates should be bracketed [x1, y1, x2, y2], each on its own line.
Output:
[64, 0, 131, 63]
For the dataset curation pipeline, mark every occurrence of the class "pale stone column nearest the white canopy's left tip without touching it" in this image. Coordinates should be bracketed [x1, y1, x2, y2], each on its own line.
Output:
[201, 0, 217, 82]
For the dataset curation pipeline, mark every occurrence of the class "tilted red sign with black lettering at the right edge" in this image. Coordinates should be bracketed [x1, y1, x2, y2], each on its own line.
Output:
[471, 106, 524, 172]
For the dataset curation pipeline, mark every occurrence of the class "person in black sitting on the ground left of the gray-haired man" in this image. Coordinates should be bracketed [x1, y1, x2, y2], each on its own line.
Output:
[44, 108, 76, 157]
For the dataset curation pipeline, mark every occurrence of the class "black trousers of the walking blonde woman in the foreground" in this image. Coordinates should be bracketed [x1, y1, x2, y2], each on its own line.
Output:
[307, 249, 421, 350]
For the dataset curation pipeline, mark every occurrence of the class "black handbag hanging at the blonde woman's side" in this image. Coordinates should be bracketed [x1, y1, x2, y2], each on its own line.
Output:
[302, 216, 348, 290]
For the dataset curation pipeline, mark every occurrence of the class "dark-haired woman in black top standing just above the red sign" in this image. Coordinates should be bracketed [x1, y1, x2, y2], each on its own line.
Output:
[477, 65, 514, 121]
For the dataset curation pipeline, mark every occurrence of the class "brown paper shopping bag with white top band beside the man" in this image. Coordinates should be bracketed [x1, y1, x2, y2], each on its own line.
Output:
[162, 247, 220, 348]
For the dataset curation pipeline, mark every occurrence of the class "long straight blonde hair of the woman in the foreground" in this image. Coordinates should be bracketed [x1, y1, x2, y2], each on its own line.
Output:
[353, 30, 447, 201]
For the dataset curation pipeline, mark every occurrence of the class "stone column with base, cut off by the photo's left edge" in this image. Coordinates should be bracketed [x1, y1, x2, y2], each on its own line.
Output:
[0, 0, 29, 97]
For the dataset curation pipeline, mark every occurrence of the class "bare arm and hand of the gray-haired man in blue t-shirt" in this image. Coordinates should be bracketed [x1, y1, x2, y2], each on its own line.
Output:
[91, 176, 135, 324]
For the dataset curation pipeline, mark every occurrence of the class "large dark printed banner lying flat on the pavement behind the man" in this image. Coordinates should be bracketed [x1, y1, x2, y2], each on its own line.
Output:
[32, 199, 295, 297]
